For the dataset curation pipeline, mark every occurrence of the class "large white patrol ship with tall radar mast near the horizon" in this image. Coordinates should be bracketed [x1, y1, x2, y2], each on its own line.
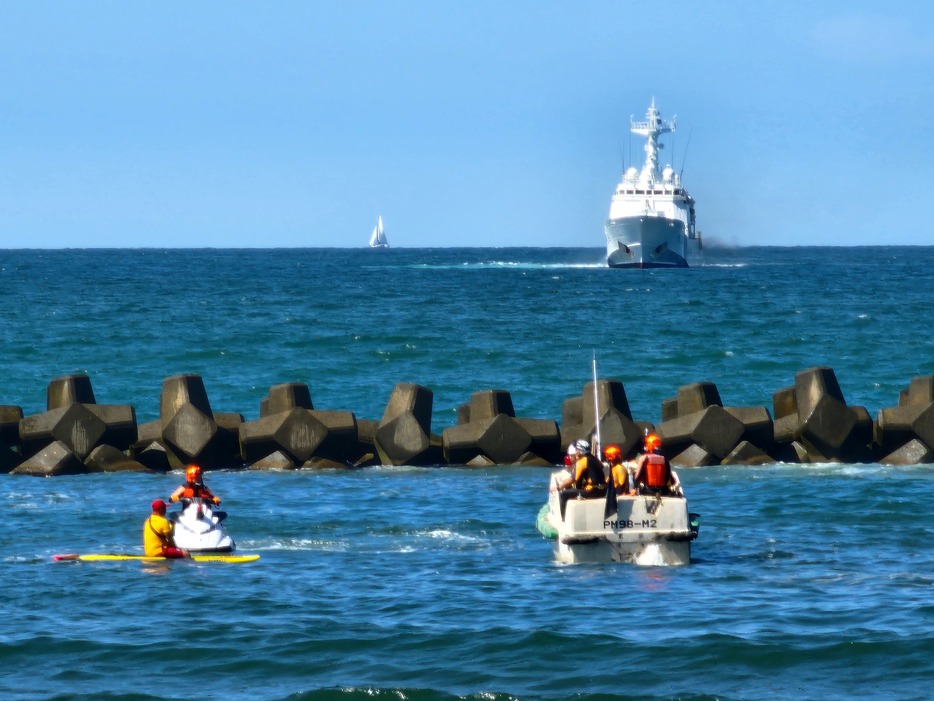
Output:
[604, 98, 701, 268]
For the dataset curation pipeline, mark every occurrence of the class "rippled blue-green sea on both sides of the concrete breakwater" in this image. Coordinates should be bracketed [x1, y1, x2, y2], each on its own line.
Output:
[0, 247, 934, 701]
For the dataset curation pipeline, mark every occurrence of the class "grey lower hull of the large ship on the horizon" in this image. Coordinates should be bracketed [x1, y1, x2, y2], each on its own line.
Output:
[605, 216, 688, 268]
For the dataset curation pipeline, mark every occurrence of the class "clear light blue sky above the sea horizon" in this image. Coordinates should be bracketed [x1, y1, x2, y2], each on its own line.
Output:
[0, 0, 934, 248]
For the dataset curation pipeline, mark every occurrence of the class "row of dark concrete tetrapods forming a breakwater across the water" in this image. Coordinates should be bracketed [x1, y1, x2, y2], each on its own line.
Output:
[0, 367, 934, 477]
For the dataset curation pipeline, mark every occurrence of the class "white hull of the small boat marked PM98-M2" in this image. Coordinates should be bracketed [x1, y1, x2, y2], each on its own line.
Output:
[537, 470, 697, 566]
